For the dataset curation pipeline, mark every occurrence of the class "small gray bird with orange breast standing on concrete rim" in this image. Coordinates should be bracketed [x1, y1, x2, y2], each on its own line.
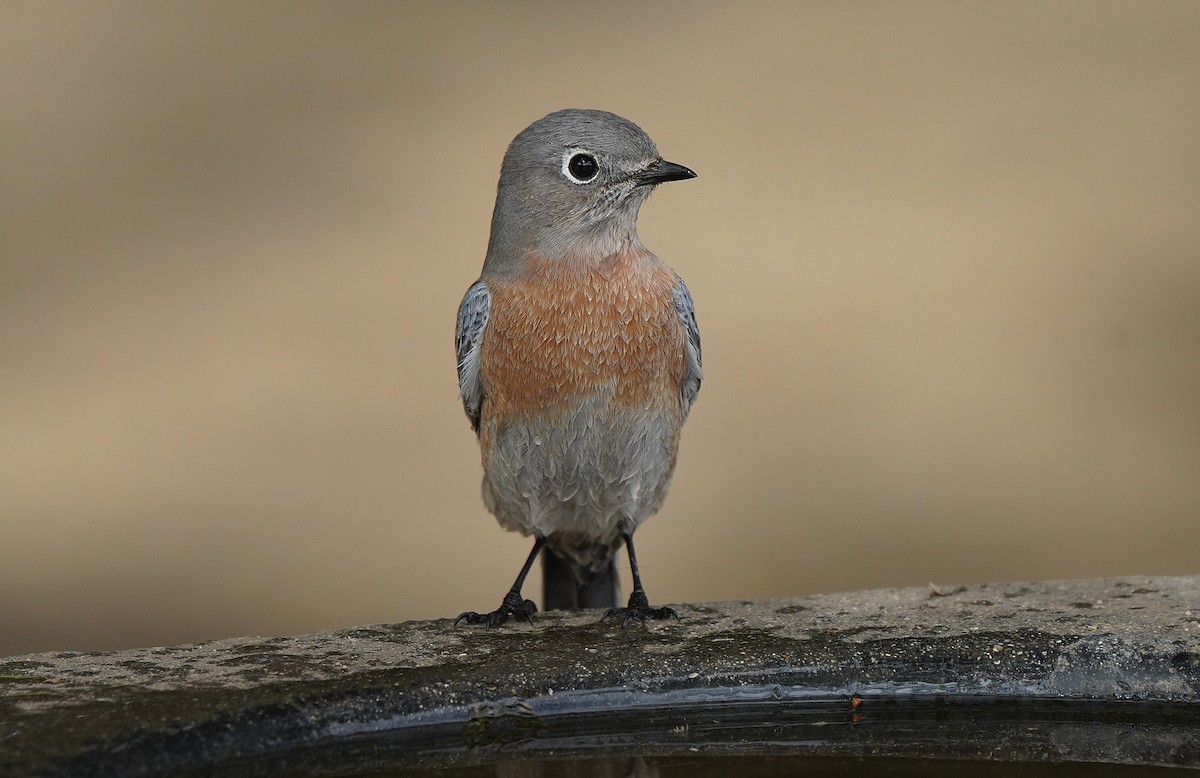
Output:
[455, 108, 703, 627]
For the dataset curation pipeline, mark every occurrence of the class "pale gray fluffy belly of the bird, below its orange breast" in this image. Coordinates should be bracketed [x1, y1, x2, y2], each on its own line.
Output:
[484, 408, 679, 550]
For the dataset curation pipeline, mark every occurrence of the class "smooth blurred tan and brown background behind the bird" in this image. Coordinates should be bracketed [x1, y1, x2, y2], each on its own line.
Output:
[0, 1, 1200, 654]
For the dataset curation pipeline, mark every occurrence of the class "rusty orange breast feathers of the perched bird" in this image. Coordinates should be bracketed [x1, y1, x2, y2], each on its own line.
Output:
[480, 250, 685, 424]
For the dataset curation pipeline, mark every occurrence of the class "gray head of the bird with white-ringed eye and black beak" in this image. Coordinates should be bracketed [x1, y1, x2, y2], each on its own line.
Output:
[485, 108, 696, 270]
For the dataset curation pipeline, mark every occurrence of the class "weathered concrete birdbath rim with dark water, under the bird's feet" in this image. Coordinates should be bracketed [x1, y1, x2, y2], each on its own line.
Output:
[0, 576, 1200, 776]
